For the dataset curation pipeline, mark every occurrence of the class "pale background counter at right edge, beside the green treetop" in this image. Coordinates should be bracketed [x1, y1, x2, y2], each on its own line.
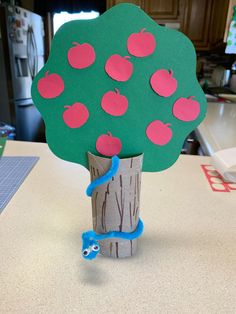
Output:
[195, 102, 236, 156]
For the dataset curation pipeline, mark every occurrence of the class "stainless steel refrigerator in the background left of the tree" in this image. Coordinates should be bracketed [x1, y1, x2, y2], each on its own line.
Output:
[0, 3, 44, 141]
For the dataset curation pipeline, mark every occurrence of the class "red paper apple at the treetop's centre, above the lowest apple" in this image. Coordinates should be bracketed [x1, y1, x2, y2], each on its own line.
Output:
[101, 88, 128, 116]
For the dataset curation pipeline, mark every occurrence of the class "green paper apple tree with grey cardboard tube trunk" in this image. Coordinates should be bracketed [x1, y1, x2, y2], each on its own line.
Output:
[32, 4, 206, 257]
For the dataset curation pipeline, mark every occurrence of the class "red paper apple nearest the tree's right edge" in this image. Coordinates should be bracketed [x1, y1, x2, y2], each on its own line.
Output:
[173, 96, 200, 121]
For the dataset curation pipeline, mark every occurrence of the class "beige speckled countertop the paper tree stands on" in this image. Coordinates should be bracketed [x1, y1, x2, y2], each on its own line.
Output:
[0, 142, 236, 314]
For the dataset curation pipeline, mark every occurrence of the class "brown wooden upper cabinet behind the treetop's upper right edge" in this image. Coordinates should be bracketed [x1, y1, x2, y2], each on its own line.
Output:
[107, 0, 229, 51]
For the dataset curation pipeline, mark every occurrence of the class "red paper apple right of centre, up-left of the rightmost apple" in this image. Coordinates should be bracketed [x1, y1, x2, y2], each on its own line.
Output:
[150, 69, 177, 97]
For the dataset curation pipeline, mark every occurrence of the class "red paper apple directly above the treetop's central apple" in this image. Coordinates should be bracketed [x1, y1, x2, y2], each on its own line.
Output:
[105, 54, 133, 82]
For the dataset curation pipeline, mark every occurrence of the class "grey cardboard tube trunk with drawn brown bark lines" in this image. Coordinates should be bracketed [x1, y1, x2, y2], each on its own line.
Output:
[88, 153, 143, 258]
